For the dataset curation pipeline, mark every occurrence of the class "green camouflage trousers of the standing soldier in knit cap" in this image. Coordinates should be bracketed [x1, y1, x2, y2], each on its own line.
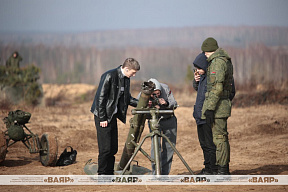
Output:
[212, 118, 230, 166]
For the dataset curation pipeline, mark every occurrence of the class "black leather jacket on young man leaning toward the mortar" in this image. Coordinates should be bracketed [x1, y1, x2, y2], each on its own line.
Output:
[90, 65, 138, 123]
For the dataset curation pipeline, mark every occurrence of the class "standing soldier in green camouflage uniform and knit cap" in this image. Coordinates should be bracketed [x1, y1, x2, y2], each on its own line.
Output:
[201, 37, 234, 175]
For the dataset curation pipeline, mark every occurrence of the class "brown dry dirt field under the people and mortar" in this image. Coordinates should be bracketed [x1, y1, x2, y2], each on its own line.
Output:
[0, 85, 288, 192]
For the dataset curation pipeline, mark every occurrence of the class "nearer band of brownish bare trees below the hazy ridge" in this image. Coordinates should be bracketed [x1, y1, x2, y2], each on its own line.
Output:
[2, 44, 288, 88]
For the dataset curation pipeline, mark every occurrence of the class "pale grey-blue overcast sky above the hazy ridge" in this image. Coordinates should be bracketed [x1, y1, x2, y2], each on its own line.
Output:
[0, 0, 288, 32]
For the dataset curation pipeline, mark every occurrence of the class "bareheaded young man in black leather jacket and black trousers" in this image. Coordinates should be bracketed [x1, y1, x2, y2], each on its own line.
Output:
[91, 58, 140, 175]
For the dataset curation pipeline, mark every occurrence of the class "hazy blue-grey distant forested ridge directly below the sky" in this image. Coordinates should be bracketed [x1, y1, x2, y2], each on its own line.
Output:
[0, 26, 288, 49]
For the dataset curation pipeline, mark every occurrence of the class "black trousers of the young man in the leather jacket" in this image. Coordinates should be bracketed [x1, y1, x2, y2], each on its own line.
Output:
[94, 115, 118, 175]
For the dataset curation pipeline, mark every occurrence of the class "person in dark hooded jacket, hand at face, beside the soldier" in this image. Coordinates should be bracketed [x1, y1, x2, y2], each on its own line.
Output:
[193, 53, 218, 175]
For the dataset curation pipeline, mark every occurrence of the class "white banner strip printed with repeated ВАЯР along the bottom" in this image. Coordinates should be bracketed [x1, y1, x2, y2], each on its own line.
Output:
[0, 175, 288, 185]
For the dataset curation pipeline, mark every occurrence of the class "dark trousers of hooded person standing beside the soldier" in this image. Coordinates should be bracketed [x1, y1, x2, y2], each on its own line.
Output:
[197, 123, 217, 171]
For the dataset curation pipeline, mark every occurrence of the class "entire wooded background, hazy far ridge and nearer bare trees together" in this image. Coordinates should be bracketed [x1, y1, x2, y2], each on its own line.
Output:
[0, 27, 288, 86]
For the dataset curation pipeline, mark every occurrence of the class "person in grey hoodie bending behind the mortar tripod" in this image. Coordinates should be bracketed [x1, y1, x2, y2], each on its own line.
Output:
[148, 78, 177, 175]
